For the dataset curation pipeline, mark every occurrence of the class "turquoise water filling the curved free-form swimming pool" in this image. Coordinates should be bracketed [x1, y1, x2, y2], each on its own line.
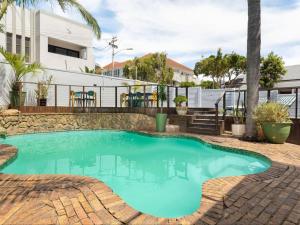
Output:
[0, 131, 270, 217]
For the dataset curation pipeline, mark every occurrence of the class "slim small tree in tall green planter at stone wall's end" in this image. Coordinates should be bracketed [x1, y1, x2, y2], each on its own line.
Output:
[156, 84, 167, 132]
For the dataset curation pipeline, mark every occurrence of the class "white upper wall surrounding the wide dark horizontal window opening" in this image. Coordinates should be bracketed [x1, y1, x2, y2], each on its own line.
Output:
[36, 11, 95, 71]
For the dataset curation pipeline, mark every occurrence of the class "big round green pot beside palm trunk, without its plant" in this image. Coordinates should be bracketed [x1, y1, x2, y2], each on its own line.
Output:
[262, 123, 292, 144]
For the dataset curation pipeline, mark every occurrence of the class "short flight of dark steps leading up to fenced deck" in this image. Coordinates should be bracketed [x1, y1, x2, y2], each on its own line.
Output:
[186, 108, 224, 135]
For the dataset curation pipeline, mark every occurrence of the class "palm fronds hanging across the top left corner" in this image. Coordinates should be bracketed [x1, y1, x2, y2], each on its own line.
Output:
[0, 0, 101, 39]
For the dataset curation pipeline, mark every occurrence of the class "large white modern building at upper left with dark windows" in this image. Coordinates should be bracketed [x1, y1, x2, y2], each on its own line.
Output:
[0, 6, 95, 71]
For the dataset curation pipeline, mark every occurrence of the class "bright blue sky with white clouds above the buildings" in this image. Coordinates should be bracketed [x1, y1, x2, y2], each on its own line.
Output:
[40, 0, 300, 68]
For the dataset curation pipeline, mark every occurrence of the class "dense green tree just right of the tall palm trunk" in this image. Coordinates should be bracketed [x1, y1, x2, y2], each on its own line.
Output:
[259, 52, 287, 88]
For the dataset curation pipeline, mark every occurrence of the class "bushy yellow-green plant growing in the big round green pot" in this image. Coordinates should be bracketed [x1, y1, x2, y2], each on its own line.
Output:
[254, 102, 291, 124]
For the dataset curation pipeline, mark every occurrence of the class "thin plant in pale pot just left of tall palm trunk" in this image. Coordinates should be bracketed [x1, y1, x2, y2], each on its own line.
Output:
[231, 90, 246, 138]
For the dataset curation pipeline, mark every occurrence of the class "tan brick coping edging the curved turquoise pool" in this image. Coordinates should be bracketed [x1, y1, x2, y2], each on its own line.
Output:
[0, 131, 298, 224]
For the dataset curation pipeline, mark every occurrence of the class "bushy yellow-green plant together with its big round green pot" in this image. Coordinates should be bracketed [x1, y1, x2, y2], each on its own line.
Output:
[254, 102, 292, 144]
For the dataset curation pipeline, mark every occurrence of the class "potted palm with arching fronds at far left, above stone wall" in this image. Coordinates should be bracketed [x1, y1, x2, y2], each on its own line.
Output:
[0, 47, 41, 108]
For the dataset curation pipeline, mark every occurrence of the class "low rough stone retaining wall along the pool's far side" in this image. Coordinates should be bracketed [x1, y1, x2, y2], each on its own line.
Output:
[0, 113, 155, 135]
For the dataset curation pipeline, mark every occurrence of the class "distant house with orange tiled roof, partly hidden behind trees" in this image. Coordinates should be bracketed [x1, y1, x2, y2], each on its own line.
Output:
[103, 54, 197, 84]
